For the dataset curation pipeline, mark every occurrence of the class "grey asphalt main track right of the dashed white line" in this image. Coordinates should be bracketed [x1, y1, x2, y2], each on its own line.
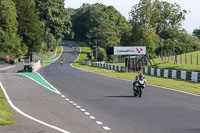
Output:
[40, 46, 200, 133]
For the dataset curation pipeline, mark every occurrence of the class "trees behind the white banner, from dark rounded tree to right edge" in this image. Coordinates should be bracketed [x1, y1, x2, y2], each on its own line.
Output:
[69, 0, 200, 60]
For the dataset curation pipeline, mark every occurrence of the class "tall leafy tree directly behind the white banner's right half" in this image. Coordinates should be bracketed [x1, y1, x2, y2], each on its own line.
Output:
[130, 0, 159, 54]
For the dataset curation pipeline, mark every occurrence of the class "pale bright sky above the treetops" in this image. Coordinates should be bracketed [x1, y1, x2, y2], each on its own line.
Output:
[65, 0, 200, 34]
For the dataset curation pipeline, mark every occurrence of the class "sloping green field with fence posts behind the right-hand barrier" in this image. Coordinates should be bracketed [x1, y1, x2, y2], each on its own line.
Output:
[148, 51, 200, 72]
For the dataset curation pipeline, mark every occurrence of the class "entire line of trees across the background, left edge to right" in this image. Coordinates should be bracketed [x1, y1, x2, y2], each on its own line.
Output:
[0, 0, 200, 61]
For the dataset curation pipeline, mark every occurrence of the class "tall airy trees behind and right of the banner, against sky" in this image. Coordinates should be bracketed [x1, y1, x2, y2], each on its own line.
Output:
[130, 0, 190, 54]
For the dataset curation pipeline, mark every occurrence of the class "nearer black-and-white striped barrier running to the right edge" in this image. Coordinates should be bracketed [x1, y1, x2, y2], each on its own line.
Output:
[143, 67, 200, 82]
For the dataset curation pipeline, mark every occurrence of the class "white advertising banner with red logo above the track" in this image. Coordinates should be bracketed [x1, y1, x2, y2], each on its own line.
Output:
[114, 46, 146, 55]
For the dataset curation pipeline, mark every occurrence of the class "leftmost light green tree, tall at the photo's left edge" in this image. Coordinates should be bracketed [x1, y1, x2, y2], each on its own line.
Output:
[0, 0, 26, 56]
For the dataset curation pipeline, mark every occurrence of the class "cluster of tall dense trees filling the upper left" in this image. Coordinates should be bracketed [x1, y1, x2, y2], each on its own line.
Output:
[0, 0, 72, 57]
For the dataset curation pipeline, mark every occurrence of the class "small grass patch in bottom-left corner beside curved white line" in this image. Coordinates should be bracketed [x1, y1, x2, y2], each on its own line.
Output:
[0, 88, 15, 126]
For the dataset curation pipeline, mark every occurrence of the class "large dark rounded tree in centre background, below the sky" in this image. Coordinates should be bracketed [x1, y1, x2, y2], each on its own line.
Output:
[72, 3, 127, 40]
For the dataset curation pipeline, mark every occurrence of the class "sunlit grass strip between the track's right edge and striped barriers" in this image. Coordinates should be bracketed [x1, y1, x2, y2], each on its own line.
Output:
[73, 42, 200, 94]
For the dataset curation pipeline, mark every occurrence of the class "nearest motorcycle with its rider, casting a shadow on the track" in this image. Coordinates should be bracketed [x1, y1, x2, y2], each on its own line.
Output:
[133, 79, 145, 97]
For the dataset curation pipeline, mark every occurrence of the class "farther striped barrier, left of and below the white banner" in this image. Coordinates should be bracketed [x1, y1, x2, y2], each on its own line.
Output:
[91, 62, 125, 72]
